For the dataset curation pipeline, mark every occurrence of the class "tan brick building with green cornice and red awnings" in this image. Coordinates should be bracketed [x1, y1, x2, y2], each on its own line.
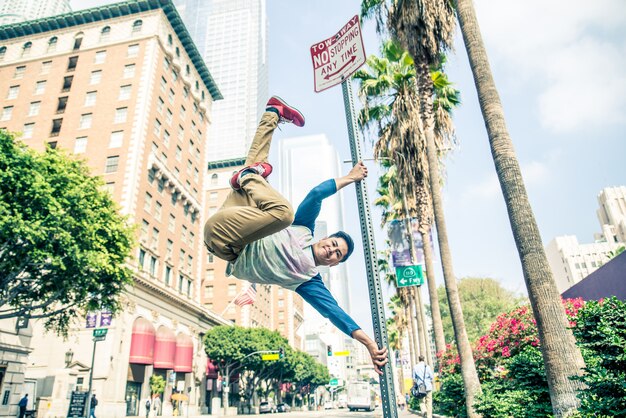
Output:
[0, 0, 230, 417]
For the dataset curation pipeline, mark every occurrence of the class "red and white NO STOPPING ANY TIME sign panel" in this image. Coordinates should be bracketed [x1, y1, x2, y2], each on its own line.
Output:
[311, 15, 365, 93]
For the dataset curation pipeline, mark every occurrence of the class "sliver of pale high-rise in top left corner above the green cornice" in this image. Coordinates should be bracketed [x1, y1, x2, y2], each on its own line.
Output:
[0, 0, 72, 25]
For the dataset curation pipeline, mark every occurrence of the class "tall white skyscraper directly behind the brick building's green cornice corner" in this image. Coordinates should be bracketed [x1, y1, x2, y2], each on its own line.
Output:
[176, 0, 268, 161]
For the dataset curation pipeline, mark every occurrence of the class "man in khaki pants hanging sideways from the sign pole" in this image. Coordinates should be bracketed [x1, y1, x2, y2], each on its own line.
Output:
[204, 96, 387, 374]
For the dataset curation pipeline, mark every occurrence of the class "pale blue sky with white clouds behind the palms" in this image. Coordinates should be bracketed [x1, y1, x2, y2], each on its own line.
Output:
[72, 0, 626, 329]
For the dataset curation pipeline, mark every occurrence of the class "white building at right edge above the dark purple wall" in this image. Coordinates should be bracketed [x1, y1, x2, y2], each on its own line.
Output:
[546, 186, 626, 293]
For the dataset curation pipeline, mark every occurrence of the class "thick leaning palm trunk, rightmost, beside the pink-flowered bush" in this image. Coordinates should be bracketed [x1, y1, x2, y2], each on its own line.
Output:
[456, 0, 584, 417]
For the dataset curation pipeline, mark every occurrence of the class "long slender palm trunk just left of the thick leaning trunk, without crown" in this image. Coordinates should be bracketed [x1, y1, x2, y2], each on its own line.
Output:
[416, 63, 481, 418]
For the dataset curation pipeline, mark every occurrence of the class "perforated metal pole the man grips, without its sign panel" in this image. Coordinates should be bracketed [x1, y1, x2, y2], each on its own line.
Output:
[341, 78, 398, 418]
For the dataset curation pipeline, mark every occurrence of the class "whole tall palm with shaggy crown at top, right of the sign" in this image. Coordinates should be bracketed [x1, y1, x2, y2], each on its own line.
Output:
[361, 0, 481, 417]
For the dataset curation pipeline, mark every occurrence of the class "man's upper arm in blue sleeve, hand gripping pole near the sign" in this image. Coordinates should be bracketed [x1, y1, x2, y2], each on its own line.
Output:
[293, 162, 367, 232]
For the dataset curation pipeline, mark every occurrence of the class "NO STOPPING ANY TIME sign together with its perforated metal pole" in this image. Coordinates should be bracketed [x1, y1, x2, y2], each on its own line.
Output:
[311, 15, 398, 418]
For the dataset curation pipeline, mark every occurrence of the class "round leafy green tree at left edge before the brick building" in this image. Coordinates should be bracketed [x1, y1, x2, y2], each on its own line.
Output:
[0, 130, 134, 334]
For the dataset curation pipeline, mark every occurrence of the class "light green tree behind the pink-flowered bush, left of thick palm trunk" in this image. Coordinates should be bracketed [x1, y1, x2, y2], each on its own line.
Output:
[437, 277, 527, 342]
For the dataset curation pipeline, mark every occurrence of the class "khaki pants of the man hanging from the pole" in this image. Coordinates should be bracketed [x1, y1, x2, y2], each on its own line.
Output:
[204, 112, 294, 261]
